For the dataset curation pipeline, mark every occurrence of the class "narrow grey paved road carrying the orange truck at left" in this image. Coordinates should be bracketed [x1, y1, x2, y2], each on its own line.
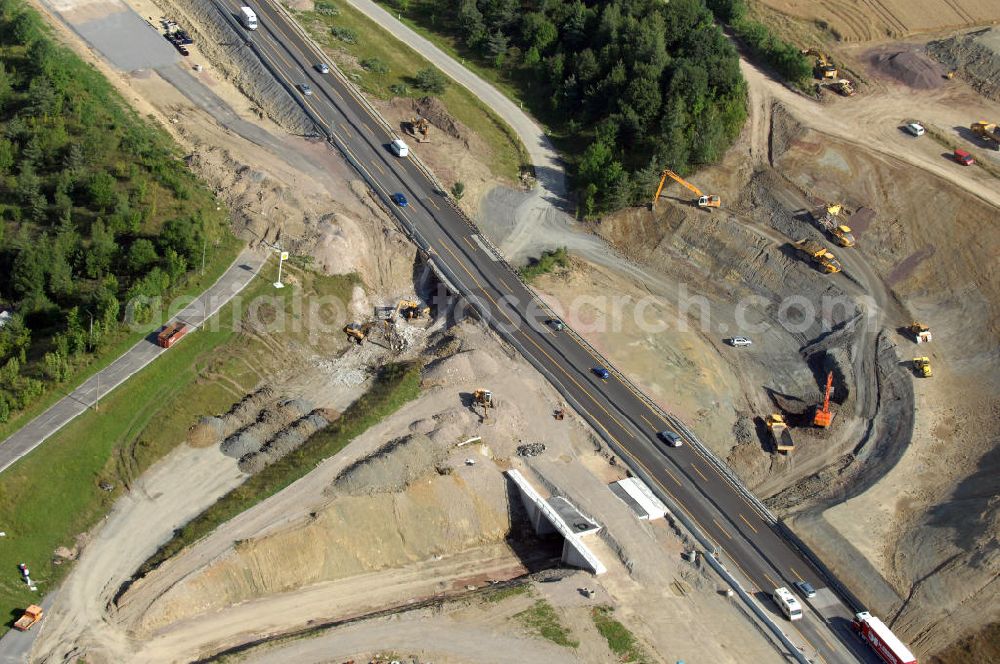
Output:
[0, 249, 267, 472]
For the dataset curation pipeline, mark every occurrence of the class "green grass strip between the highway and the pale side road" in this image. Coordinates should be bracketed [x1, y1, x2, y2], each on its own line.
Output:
[297, 2, 530, 180]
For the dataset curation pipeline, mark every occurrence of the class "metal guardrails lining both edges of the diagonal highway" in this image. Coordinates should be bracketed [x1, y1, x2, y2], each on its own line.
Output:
[213, 0, 853, 664]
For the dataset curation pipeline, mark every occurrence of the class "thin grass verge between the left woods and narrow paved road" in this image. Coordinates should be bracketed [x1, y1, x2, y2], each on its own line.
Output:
[0, 233, 243, 441]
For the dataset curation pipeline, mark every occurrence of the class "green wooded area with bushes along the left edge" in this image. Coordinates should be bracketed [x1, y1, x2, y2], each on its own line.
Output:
[0, 0, 234, 423]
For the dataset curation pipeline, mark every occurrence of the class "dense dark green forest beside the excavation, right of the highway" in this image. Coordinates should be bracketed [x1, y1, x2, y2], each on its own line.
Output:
[389, 0, 746, 217]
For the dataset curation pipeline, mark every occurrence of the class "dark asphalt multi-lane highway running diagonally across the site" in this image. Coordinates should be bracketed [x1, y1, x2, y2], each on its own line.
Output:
[215, 0, 878, 662]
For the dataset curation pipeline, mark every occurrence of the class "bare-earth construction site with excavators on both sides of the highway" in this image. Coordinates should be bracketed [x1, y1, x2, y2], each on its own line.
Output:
[0, 0, 1000, 664]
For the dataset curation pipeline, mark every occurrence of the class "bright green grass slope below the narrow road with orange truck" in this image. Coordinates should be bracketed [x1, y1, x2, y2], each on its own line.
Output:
[0, 264, 269, 628]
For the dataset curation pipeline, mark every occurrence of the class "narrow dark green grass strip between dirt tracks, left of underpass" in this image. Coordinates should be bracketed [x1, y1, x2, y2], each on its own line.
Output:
[136, 363, 420, 577]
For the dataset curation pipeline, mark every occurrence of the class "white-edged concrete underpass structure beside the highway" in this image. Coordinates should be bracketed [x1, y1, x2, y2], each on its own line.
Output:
[505, 470, 608, 574]
